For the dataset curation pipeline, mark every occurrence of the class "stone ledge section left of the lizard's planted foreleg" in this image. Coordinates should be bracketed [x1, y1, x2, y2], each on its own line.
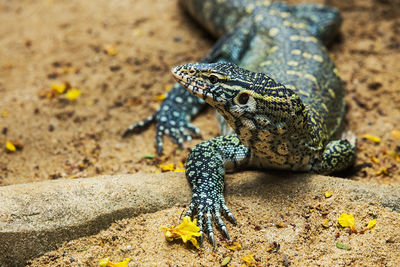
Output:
[0, 173, 190, 266]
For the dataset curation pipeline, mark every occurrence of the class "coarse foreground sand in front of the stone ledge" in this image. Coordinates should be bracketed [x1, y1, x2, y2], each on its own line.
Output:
[28, 187, 400, 266]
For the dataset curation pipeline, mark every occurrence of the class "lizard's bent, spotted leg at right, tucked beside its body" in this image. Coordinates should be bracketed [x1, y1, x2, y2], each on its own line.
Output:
[312, 136, 356, 174]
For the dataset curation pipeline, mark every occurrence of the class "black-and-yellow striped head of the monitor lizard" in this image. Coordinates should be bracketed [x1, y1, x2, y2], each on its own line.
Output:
[172, 63, 306, 151]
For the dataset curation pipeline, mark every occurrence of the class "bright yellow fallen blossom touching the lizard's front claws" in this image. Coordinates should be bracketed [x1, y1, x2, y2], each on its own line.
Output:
[162, 216, 201, 248]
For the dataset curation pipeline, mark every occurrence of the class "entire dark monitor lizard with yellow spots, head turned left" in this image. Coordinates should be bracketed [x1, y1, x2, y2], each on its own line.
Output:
[124, 0, 355, 247]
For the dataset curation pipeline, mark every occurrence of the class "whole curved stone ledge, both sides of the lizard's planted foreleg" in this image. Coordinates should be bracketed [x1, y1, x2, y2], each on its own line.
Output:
[0, 172, 400, 266]
